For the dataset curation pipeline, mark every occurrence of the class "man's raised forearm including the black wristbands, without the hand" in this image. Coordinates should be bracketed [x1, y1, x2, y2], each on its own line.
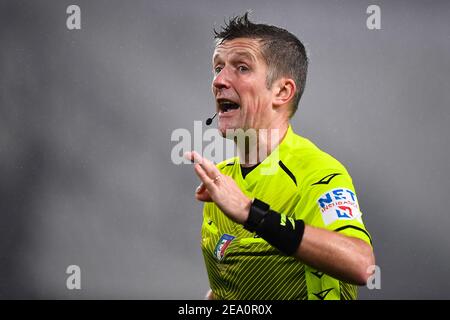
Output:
[244, 200, 374, 285]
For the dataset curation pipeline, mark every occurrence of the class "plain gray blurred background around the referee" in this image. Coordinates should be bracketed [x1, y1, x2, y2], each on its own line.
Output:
[0, 0, 450, 299]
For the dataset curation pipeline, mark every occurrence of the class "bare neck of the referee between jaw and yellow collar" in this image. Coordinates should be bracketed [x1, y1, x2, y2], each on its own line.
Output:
[234, 122, 289, 167]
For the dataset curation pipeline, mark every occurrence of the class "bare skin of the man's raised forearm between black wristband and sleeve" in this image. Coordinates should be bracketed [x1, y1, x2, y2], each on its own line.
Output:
[294, 225, 375, 285]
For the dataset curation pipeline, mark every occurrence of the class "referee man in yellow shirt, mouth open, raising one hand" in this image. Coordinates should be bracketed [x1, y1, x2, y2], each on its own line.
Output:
[186, 14, 375, 300]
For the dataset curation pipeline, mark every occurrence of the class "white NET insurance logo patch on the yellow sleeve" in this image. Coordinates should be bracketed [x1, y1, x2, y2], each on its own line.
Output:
[317, 188, 361, 225]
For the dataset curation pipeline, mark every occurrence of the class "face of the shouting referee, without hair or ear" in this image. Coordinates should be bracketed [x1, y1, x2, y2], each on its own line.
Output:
[212, 38, 272, 136]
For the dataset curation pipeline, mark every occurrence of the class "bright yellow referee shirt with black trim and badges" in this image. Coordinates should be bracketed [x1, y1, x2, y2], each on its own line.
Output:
[201, 126, 371, 300]
